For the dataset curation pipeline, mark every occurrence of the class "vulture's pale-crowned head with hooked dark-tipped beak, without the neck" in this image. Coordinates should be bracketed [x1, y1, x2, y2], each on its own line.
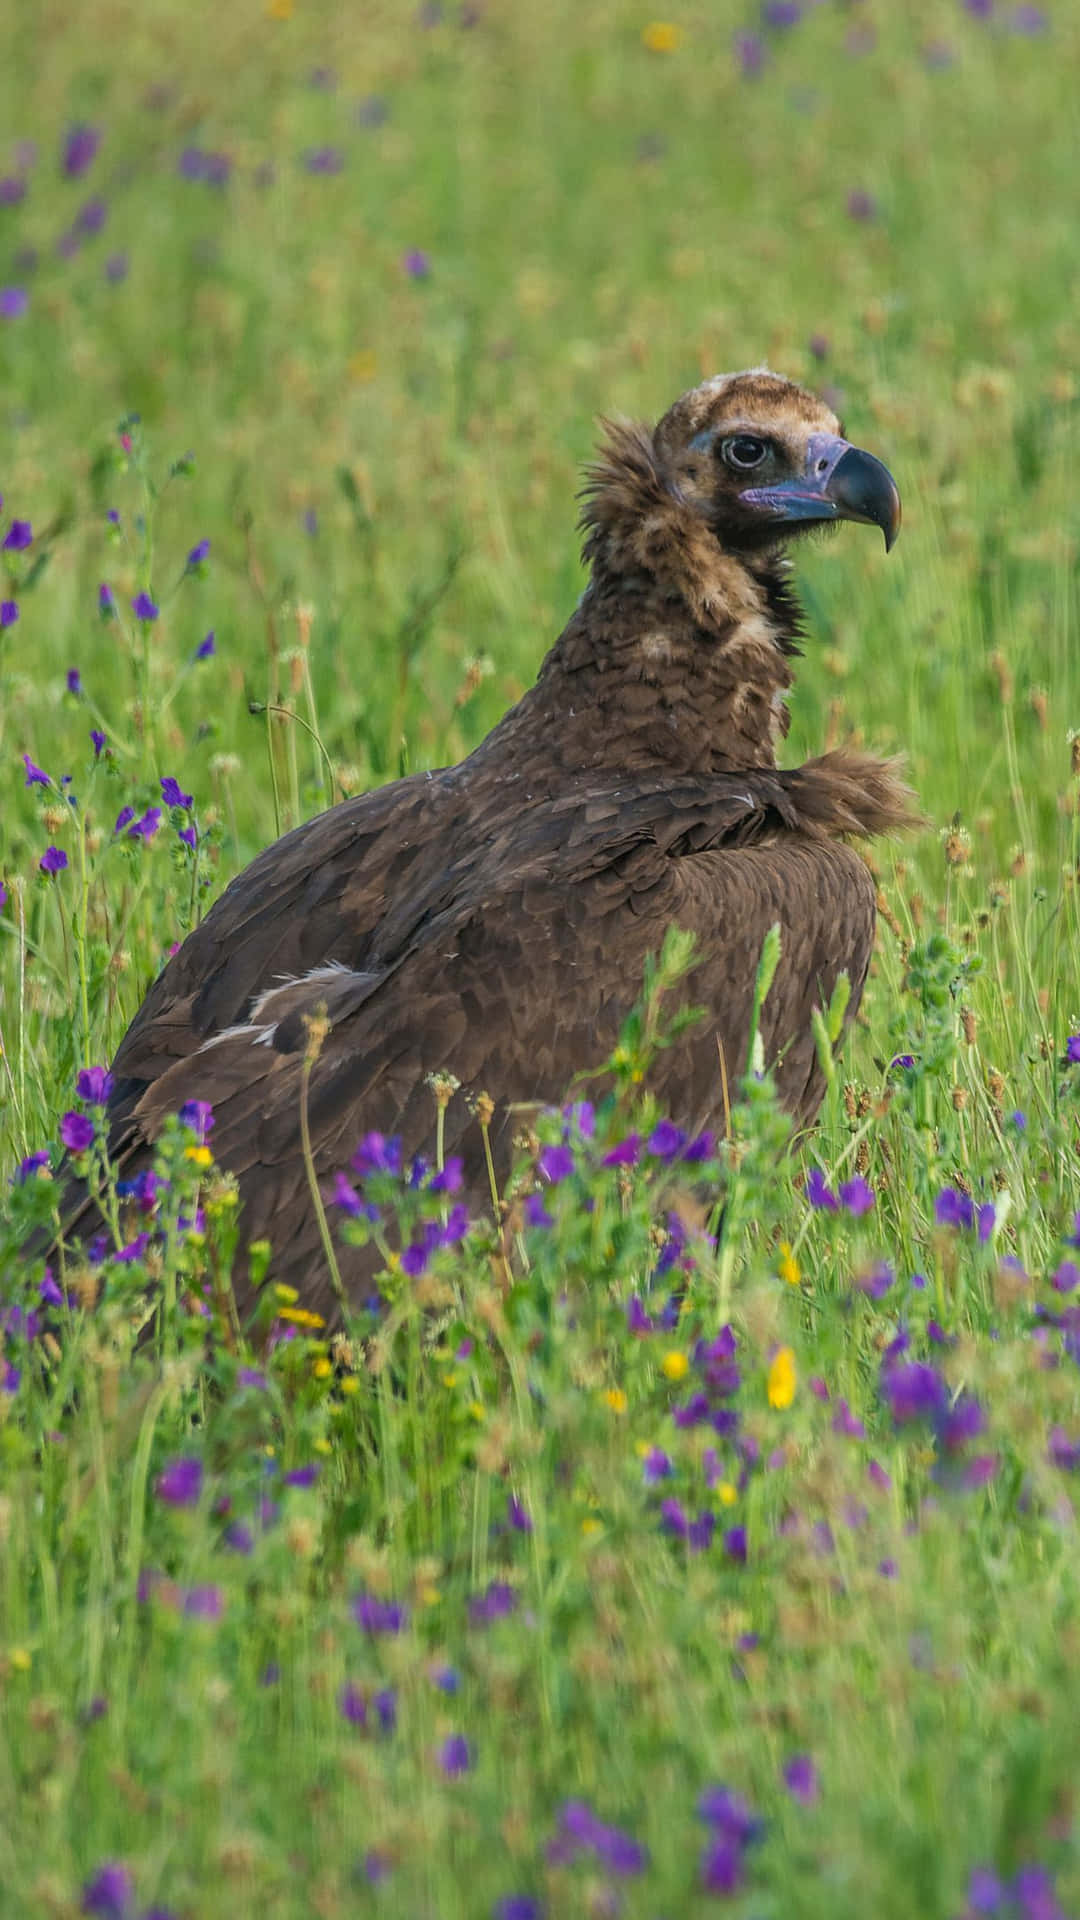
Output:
[653, 369, 899, 553]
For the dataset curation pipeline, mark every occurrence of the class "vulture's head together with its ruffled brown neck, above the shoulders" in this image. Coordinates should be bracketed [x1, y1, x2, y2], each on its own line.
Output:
[509, 372, 899, 774]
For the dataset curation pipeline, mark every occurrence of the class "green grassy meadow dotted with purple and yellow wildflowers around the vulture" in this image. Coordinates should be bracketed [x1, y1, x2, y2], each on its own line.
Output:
[0, 0, 1080, 1920]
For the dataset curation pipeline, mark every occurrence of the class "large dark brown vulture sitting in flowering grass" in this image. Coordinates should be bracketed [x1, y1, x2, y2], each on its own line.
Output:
[58, 369, 911, 1323]
